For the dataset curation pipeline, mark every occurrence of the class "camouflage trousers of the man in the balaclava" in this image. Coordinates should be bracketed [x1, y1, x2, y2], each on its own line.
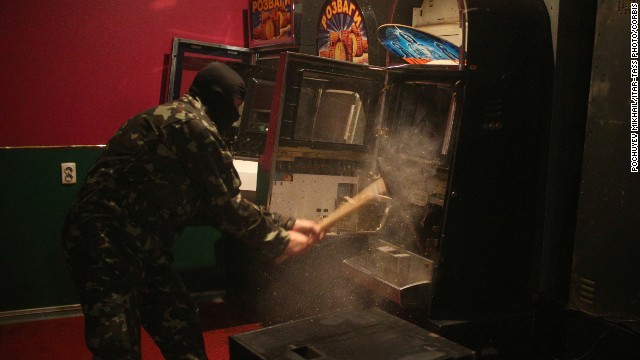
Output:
[65, 229, 207, 360]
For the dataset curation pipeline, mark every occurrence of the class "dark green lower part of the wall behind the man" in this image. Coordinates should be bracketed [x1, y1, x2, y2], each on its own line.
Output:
[0, 146, 220, 312]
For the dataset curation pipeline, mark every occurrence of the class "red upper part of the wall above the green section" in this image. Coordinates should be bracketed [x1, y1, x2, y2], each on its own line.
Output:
[0, 0, 248, 147]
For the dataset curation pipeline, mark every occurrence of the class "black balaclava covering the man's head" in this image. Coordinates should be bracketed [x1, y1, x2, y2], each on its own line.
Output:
[189, 62, 246, 137]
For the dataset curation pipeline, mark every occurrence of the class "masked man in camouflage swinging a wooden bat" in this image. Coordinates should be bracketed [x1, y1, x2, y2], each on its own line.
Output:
[62, 63, 324, 359]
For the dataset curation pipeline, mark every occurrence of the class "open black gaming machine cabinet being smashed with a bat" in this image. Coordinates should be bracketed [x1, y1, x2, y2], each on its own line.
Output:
[260, 2, 553, 319]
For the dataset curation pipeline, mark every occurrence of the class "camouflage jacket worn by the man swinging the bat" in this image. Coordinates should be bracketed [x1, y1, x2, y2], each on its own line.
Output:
[63, 95, 295, 265]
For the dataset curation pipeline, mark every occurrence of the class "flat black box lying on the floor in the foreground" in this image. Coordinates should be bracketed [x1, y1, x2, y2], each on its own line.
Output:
[229, 309, 475, 360]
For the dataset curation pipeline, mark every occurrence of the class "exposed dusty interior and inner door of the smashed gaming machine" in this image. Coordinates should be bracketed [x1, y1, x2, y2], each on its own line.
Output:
[269, 57, 458, 307]
